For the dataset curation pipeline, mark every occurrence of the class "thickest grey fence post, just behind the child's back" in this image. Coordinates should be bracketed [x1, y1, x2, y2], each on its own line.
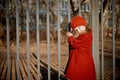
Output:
[91, 0, 100, 80]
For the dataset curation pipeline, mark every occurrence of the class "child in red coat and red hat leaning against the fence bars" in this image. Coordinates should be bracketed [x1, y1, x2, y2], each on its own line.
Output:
[65, 16, 96, 80]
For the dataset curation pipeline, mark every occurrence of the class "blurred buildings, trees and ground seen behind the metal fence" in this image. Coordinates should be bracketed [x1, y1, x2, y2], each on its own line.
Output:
[0, 0, 120, 80]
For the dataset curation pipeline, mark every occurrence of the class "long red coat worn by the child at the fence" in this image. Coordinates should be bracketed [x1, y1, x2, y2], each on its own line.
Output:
[65, 32, 96, 80]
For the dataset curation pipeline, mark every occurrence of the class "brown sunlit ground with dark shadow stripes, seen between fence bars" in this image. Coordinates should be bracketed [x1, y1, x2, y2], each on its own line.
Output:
[0, 40, 120, 80]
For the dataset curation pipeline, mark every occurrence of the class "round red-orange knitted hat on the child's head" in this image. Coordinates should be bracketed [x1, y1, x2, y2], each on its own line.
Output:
[70, 16, 87, 29]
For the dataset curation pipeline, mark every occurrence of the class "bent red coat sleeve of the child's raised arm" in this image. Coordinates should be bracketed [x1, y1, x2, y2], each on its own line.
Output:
[68, 36, 87, 48]
